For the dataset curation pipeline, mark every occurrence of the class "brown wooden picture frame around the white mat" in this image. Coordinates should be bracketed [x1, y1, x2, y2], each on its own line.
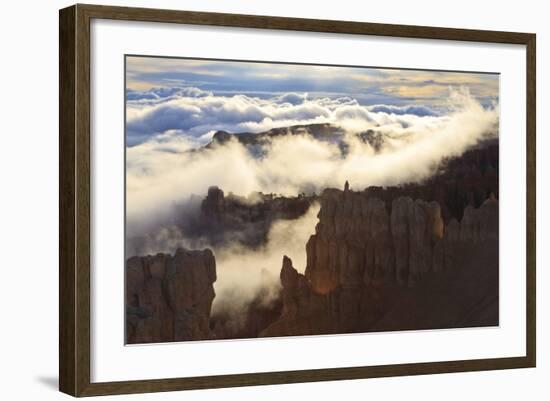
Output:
[59, 4, 536, 396]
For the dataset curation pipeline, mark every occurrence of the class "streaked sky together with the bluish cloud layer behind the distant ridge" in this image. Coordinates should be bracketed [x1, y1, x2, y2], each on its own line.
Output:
[126, 56, 499, 146]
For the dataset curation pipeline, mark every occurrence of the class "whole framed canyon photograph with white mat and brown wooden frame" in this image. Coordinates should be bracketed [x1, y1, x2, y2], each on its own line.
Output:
[59, 5, 536, 396]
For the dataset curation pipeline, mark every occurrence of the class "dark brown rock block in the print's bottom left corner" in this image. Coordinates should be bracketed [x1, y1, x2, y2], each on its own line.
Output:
[126, 248, 216, 343]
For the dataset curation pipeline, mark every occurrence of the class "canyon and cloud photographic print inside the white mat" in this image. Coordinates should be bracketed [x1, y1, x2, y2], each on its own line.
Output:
[124, 55, 499, 344]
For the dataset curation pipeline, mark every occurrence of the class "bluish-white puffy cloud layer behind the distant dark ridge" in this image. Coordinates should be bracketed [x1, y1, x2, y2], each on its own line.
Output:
[126, 88, 452, 146]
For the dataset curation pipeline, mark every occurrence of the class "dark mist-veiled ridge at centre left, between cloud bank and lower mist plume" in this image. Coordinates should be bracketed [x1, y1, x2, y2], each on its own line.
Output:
[126, 186, 316, 256]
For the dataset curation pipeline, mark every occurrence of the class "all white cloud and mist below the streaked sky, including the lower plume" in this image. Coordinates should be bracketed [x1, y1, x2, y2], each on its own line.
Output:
[127, 88, 499, 316]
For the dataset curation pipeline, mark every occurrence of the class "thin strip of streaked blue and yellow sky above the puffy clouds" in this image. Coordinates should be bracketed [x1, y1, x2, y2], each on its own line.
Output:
[126, 56, 498, 105]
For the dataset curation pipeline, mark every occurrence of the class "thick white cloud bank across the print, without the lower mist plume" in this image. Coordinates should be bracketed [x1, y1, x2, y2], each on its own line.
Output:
[127, 90, 498, 225]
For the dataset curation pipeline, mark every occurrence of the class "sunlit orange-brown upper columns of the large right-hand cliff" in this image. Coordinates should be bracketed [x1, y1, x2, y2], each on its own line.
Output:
[305, 189, 450, 294]
